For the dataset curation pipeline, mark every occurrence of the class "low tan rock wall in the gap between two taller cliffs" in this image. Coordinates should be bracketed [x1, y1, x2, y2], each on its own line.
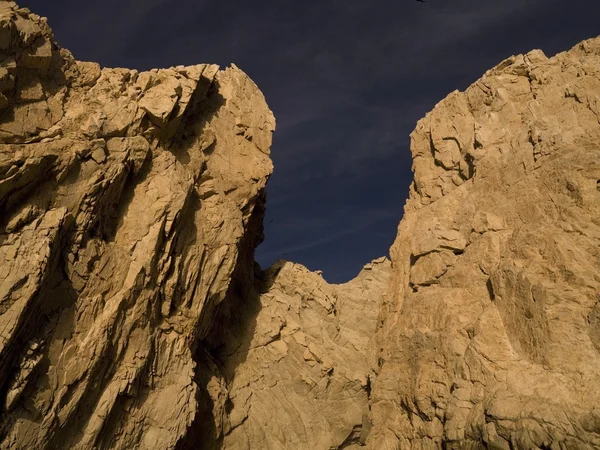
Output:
[211, 258, 390, 450]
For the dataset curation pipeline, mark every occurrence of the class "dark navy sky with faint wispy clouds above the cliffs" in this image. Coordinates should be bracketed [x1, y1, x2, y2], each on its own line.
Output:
[19, 0, 600, 282]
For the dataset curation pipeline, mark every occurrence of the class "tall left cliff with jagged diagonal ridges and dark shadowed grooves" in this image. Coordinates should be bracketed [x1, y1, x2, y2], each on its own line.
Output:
[0, 1, 274, 449]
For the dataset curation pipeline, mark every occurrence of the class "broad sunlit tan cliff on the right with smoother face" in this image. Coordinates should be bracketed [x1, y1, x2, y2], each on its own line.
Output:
[368, 38, 600, 450]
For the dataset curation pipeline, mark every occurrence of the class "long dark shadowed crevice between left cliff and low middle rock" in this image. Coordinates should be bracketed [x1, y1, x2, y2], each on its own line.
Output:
[176, 187, 284, 450]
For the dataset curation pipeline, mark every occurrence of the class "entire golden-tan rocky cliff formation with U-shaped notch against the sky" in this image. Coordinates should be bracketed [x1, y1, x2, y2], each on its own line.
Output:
[0, 2, 600, 450]
